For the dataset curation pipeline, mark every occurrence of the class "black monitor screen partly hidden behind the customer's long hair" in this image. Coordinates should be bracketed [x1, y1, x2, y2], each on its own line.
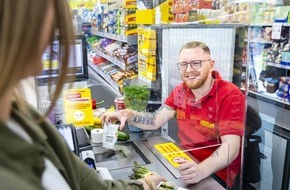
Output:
[37, 35, 88, 84]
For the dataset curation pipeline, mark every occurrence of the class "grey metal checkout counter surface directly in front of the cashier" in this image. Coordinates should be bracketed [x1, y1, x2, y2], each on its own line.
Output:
[82, 127, 225, 190]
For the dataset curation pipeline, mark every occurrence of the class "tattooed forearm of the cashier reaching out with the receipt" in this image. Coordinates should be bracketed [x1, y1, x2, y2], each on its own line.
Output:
[127, 112, 156, 126]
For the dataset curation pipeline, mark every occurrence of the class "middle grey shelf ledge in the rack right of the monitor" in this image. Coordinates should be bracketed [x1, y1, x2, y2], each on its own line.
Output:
[92, 48, 138, 70]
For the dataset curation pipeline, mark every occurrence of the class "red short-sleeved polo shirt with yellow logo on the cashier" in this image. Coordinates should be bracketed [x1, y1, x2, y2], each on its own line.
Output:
[165, 71, 245, 187]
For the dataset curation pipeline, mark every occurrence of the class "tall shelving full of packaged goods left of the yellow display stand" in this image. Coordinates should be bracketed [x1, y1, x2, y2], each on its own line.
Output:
[87, 0, 138, 92]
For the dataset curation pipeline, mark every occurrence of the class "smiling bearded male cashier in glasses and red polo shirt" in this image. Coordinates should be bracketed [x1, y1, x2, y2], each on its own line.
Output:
[103, 41, 245, 187]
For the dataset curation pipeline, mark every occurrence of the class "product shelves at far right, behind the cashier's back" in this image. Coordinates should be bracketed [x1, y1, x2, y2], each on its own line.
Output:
[248, 23, 290, 105]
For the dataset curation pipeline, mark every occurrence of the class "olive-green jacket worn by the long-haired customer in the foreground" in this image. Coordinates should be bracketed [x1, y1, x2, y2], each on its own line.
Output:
[0, 106, 143, 190]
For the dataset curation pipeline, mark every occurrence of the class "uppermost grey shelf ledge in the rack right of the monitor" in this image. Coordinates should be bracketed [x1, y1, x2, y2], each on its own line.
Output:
[91, 28, 137, 45]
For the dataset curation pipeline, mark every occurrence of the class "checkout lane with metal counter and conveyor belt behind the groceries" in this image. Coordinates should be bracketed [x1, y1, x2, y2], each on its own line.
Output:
[88, 74, 225, 190]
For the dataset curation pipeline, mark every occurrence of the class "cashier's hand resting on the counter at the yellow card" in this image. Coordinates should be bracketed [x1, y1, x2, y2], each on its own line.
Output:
[178, 160, 207, 184]
